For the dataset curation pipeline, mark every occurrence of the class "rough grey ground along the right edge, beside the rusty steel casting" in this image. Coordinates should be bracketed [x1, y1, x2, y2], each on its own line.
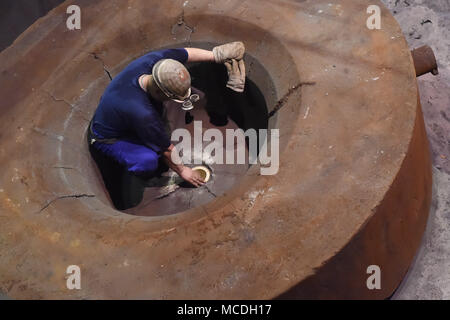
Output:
[383, 0, 450, 299]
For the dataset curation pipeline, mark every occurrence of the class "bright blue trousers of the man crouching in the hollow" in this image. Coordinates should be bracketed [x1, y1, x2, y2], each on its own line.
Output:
[94, 136, 160, 178]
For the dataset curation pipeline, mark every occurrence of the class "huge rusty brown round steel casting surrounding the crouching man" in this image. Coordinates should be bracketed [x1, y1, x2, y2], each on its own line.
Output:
[0, 0, 431, 299]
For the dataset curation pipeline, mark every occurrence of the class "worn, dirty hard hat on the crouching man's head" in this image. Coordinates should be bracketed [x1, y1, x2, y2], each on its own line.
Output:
[152, 59, 191, 103]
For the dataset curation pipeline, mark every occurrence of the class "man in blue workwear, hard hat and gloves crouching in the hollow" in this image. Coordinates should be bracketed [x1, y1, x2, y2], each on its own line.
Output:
[89, 42, 245, 209]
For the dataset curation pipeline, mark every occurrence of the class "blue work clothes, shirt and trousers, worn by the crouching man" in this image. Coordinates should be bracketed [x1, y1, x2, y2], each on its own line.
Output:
[92, 49, 188, 177]
